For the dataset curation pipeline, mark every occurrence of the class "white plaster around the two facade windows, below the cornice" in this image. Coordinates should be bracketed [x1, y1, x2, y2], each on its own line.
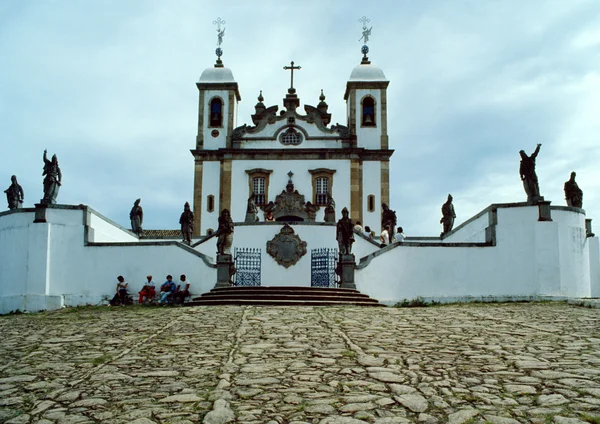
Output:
[231, 160, 350, 222]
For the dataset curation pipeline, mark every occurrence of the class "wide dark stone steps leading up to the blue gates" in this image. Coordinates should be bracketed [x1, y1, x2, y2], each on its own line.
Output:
[186, 286, 385, 306]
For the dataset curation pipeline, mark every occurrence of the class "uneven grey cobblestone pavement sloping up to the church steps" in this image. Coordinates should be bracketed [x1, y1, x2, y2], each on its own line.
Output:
[0, 303, 600, 424]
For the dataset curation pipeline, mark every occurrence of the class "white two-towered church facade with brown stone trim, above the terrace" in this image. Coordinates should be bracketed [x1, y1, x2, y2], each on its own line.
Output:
[192, 54, 393, 236]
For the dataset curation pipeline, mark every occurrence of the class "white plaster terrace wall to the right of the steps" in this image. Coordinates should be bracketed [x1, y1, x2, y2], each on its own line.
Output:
[356, 207, 590, 302]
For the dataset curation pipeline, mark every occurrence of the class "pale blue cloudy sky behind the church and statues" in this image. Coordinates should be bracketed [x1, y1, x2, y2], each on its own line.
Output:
[0, 0, 600, 236]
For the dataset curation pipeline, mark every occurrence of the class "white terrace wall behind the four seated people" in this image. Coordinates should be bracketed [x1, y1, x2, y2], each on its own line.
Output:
[0, 207, 216, 314]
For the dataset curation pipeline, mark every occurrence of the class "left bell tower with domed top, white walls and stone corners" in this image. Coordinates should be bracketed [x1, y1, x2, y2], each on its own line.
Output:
[192, 18, 241, 236]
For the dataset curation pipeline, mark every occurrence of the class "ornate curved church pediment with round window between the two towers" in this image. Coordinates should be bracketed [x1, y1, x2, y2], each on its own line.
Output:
[232, 93, 350, 149]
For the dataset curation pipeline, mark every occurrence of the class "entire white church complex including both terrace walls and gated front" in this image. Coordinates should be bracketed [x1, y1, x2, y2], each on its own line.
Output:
[0, 33, 600, 314]
